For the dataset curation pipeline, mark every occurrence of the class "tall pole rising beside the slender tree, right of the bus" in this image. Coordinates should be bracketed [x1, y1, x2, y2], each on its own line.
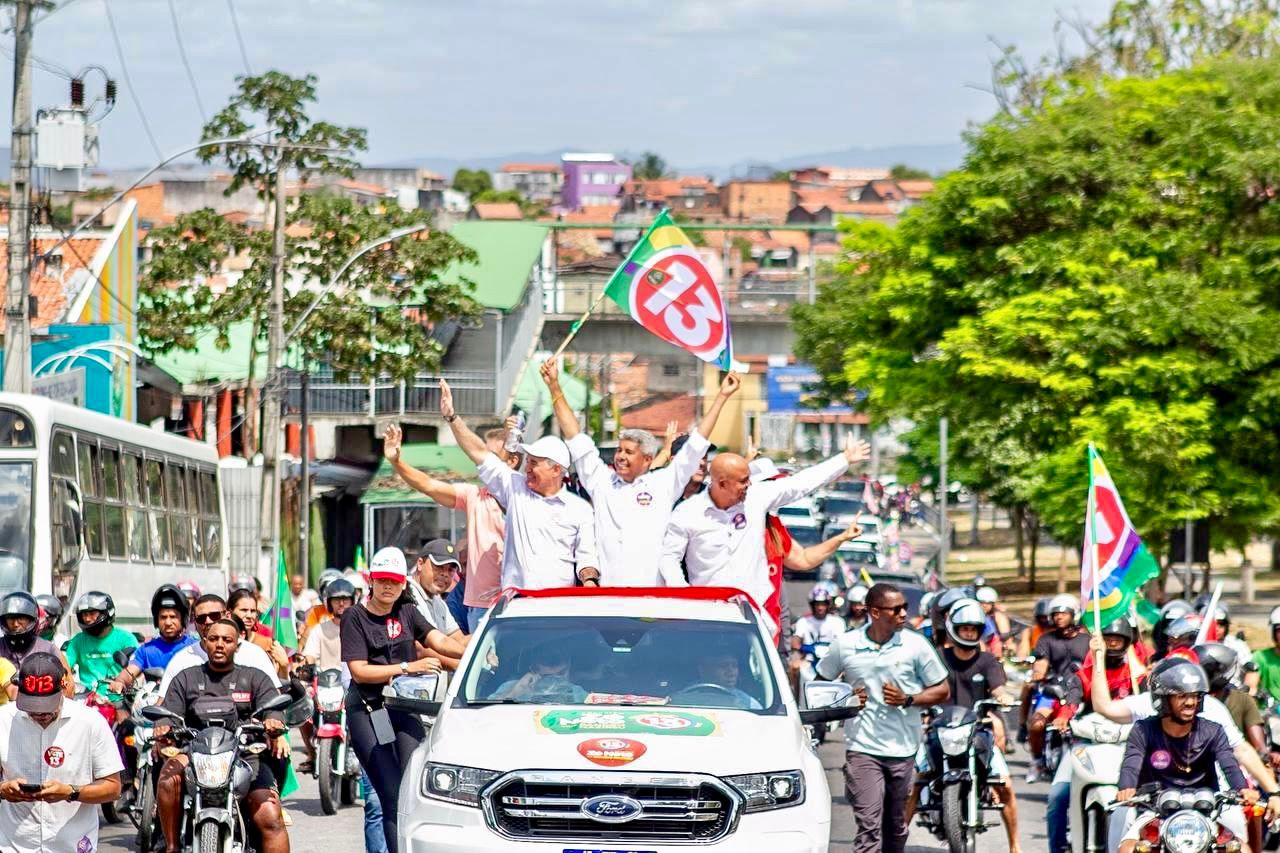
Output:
[259, 145, 285, 578]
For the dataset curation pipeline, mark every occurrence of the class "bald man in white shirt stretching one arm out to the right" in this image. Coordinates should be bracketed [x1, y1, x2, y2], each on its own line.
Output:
[662, 438, 870, 628]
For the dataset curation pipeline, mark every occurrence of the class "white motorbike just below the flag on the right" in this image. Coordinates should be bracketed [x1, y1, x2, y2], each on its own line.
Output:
[1069, 713, 1133, 853]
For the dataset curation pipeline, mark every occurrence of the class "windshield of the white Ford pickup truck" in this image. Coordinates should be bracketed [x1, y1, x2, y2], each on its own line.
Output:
[461, 616, 786, 713]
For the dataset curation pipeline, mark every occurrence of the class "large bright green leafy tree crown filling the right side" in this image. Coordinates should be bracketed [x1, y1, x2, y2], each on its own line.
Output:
[795, 60, 1280, 552]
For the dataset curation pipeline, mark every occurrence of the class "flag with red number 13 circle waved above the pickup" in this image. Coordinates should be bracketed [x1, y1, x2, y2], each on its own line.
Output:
[601, 210, 733, 370]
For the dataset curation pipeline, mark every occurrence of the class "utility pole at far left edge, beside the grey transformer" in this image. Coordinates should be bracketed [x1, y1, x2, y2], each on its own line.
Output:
[4, 0, 36, 393]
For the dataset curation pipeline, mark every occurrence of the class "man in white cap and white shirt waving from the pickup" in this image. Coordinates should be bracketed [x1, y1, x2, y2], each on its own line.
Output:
[440, 380, 600, 589]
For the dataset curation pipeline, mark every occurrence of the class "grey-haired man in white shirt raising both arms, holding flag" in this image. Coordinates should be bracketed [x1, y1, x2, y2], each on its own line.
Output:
[541, 361, 742, 587]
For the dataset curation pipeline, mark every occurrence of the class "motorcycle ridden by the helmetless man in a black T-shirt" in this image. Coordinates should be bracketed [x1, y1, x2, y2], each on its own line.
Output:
[142, 694, 291, 853]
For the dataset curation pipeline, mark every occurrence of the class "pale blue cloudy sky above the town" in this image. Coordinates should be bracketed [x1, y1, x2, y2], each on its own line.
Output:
[0, 0, 1111, 167]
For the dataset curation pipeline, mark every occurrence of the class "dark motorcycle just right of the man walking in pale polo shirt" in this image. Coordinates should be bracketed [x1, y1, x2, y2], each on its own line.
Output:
[916, 699, 1002, 853]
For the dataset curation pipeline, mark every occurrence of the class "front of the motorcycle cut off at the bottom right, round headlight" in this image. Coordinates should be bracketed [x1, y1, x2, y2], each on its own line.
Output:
[1107, 784, 1253, 853]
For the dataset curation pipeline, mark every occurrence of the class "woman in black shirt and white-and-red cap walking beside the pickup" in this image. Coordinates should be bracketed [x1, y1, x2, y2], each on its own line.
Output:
[342, 548, 440, 850]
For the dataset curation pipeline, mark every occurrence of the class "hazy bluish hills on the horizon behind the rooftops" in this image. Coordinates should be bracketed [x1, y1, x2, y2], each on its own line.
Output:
[381, 142, 965, 181]
